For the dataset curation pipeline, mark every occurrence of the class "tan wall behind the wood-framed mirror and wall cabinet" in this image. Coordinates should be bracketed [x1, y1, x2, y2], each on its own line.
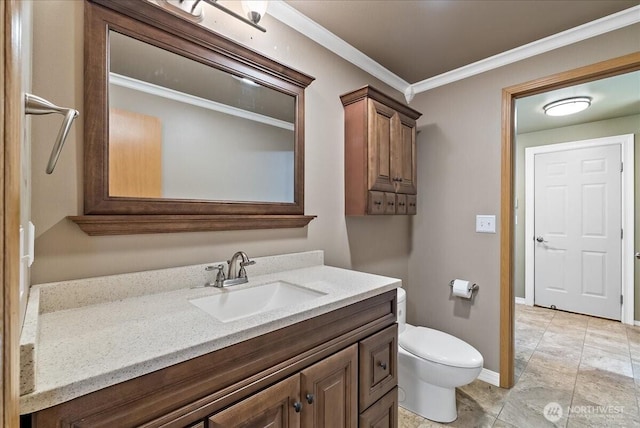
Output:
[32, 1, 410, 284]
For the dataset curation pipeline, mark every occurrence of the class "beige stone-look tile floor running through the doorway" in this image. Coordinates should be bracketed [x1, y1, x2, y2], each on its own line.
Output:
[399, 305, 640, 428]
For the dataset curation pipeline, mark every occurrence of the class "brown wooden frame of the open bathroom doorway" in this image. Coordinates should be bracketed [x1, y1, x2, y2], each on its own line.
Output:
[500, 52, 640, 388]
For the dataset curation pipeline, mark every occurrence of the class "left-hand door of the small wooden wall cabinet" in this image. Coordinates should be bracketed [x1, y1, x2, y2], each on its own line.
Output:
[367, 99, 398, 192]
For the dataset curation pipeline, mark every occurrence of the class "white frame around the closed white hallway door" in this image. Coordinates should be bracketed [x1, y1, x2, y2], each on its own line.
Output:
[524, 134, 634, 325]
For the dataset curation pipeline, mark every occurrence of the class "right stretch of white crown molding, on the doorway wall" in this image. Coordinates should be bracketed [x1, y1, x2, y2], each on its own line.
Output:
[411, 6, 640, 94]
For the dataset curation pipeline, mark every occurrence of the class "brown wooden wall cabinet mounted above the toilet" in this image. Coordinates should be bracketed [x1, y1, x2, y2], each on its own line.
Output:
[340, 86, 421, 215]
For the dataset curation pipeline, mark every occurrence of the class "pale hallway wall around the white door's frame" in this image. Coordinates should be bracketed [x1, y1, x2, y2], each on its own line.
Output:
[514, 115, 640, 319]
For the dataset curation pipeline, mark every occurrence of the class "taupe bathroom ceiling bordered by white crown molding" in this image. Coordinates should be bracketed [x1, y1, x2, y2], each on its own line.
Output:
[286, 0, 640, 84]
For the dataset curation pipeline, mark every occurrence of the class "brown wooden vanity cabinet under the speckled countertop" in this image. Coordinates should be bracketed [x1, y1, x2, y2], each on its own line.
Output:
[28, 289, 397, 428]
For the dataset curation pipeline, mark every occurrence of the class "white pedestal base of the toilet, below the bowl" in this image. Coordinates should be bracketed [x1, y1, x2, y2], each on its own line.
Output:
[398, 366, 458, 423]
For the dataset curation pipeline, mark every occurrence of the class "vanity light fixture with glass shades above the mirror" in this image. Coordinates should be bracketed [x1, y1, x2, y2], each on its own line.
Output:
[158, 0, 268, 33]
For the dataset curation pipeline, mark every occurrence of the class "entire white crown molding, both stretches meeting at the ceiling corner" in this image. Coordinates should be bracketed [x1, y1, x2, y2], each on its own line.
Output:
[268, 0, 640, 102]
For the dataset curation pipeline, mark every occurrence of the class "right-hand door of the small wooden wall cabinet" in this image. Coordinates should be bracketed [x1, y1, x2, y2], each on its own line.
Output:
[391, 114, 417, 195]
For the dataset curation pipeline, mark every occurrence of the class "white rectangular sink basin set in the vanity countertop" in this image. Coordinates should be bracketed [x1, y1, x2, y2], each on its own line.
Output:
[189, 281, 325, 322]
